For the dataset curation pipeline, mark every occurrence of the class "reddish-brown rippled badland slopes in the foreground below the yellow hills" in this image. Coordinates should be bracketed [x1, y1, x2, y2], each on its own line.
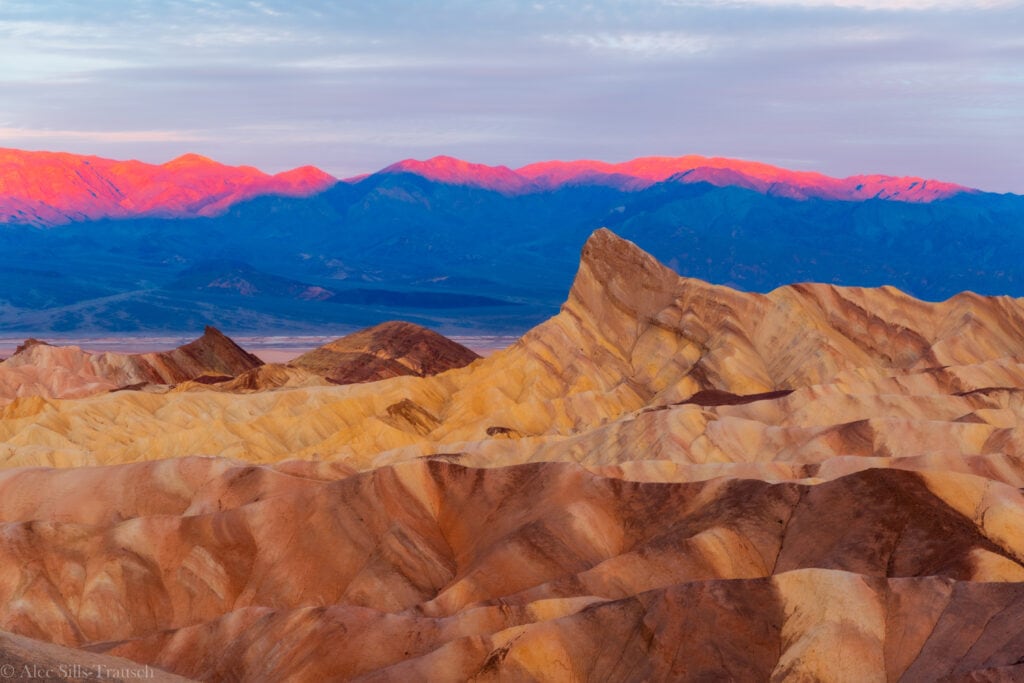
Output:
[0, 461, 1024, 680]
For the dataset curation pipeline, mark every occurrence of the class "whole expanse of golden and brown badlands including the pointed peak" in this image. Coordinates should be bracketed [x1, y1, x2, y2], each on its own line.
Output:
[0, 231, 1024, 681]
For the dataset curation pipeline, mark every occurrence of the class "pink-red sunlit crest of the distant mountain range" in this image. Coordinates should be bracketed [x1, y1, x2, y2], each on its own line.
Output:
[0, 148, 977, 226]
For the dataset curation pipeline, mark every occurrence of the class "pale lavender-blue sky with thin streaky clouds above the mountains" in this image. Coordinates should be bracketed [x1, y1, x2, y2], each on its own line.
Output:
[0, 0, 1024, 194]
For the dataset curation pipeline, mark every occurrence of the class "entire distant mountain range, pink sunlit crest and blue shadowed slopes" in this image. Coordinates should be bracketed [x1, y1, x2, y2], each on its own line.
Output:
[0, 150, 1024, 335]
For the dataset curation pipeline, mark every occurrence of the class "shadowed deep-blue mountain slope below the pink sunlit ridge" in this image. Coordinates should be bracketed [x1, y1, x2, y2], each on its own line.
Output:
[0, 173, 1024, 333]
